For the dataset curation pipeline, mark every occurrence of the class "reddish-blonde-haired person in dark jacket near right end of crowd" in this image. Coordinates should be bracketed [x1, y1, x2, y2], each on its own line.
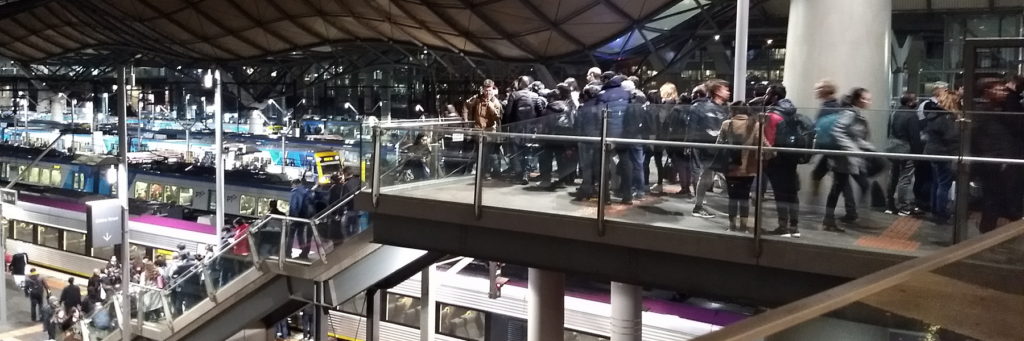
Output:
[922, 90, 964, 224]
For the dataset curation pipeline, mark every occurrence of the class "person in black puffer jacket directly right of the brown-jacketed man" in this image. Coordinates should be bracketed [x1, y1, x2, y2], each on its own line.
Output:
[503, 76, 547, 185]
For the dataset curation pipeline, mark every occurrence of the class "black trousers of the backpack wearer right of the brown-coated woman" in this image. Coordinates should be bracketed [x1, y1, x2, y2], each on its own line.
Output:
[762, 157, 800, 227]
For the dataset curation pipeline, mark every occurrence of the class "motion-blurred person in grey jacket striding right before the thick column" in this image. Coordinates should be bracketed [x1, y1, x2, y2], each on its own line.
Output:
[823, 88, 874, 232]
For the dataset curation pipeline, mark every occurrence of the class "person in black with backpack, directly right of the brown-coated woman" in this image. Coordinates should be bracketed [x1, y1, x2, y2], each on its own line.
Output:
[762, 85, 814, 238]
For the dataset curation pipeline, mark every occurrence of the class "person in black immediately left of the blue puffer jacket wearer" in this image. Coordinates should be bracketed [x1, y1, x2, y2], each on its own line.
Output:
[573, 85, 601, 201]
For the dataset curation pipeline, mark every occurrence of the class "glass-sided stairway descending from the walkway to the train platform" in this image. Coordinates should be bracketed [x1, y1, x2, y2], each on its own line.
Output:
[99, 191, 445, 340]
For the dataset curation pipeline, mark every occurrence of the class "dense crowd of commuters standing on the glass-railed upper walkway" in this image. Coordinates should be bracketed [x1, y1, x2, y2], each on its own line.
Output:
[464, 68, 1024, 237]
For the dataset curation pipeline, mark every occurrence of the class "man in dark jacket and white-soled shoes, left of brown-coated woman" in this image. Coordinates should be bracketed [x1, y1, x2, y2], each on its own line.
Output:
[687, 79, 732, 218]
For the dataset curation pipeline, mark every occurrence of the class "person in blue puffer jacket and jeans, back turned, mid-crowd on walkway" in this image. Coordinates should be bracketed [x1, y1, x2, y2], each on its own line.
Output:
[598, 76, 634, 205]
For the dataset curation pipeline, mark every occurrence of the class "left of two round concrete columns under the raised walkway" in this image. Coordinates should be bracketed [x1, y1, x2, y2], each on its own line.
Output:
[526, 267, 565, 341]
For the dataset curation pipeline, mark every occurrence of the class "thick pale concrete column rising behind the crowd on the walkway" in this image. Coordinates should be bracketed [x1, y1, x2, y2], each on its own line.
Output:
[783, 0, 892, 144]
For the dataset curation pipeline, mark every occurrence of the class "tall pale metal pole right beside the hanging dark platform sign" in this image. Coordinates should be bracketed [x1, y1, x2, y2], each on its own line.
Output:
[118, 67, 132, 340]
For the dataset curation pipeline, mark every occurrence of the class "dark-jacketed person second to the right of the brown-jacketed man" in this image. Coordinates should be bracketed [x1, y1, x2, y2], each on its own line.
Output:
[538, 84, 577, 189]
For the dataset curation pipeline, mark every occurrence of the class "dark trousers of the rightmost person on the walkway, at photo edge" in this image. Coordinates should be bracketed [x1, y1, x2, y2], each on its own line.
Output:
[977, 164, 1024, 232]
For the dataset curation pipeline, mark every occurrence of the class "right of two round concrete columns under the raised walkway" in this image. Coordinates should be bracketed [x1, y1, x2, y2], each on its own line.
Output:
[611, 282, 643, 341]
